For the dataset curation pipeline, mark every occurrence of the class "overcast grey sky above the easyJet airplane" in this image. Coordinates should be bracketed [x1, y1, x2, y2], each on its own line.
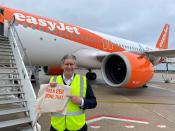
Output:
[0, 0, 175, 48]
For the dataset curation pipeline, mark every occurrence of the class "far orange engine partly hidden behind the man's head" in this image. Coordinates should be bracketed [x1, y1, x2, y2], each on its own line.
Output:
[43, 66, 63, 75]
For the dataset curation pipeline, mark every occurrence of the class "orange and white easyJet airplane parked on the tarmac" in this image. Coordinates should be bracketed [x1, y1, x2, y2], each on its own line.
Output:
[0, 6, 175, 89]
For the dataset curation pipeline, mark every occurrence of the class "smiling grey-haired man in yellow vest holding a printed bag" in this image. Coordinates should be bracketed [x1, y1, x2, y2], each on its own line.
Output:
[50, 55, 97, 131]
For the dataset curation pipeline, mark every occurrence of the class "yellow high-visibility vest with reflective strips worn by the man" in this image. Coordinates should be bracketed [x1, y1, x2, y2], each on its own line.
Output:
[50, 74, 87, 131]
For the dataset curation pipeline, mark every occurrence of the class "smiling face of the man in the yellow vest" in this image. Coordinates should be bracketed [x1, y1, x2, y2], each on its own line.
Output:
[63, 59, 76, 76]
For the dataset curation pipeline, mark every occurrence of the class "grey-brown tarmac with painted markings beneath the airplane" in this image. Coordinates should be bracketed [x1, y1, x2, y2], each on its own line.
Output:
[0, 70, 175, 131]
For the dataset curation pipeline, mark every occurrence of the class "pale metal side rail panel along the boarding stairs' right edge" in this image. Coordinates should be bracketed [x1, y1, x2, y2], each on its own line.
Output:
[8, 17, 38, 130]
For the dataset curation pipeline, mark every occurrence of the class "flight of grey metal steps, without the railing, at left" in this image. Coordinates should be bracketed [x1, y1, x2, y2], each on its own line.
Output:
[0, 35, 34, 131]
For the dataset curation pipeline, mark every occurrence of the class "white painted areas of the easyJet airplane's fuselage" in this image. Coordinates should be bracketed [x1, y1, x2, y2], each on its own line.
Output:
[9, 25, 157, 66]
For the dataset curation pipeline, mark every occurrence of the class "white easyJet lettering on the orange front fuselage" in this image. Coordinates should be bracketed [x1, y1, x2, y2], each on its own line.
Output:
[14, 13, 80, 35]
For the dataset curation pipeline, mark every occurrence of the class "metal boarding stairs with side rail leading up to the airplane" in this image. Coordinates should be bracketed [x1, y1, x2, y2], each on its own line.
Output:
[0, 24, 38, 131]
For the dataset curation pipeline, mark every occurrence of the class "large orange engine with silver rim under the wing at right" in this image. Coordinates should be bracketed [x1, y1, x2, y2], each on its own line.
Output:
[102, 52, 154, 88]
